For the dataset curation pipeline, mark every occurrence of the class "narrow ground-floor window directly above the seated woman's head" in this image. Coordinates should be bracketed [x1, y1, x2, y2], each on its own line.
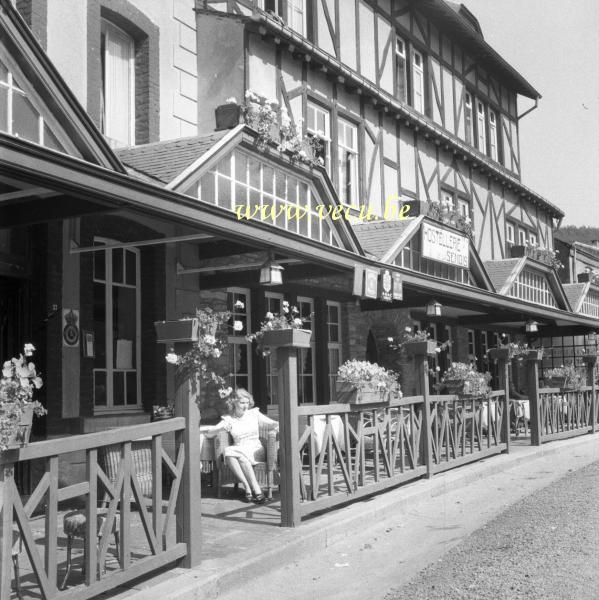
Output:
[227, 288, 252, 392]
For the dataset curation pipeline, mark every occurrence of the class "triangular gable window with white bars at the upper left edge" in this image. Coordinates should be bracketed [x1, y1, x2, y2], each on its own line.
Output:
[0, 61, 64, 152]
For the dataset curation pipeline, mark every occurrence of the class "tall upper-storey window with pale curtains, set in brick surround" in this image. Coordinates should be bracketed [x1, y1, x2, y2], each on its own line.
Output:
[100, 20, 135, 147]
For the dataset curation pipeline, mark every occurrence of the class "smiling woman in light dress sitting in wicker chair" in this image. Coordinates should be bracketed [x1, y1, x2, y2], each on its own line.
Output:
[206, 388, 279, 504]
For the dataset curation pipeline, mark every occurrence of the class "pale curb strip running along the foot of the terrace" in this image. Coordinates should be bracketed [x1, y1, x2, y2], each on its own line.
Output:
[126, 435, 599, 600]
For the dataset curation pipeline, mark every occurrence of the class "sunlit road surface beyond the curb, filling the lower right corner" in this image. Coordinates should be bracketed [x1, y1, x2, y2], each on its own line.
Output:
[212, 448, 599, 600]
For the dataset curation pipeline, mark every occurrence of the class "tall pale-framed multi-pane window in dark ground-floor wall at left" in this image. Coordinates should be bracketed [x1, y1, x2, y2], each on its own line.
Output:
[92, 236, 143, 415]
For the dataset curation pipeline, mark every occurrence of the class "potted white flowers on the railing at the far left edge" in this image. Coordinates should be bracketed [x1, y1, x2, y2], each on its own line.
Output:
[0, 344, 47, 450]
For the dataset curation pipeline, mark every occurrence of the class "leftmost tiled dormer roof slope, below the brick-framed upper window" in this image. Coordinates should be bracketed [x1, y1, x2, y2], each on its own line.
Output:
[116, 130, 228, 184]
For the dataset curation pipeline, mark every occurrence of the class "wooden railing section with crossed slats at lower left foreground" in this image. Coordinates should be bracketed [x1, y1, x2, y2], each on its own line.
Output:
[0, 417, 190, 600]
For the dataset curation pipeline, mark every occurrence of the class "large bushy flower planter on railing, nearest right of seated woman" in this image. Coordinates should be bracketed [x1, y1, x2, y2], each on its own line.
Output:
[336, 359, 401, 404]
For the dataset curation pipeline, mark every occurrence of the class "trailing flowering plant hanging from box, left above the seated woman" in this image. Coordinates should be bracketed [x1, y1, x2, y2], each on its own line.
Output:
[165, 307, 234, 398]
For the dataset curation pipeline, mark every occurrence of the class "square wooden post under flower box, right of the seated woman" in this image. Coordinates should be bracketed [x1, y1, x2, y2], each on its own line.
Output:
[276, 346, 301, 527]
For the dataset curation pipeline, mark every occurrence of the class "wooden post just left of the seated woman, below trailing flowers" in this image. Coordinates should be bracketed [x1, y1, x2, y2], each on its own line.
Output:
[173, 352, 202, 569]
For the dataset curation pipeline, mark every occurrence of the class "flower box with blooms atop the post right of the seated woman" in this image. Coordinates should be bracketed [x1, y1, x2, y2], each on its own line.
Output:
[246, 300, 312, 356]
